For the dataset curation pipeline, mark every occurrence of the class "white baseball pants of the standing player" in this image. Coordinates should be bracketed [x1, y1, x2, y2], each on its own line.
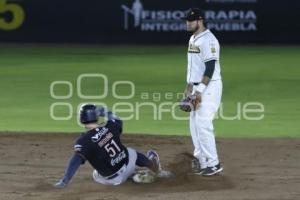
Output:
[190, 80, 223, 169]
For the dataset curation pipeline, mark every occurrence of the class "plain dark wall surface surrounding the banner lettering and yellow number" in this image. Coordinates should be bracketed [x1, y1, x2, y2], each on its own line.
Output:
[0, 0, 300, 44]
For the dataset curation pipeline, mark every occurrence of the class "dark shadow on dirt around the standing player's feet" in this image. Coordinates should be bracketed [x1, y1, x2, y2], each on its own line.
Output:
[113, 153, 234, 193]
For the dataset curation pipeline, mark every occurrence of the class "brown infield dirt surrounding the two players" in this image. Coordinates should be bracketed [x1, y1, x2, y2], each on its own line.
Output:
[0, 133, 300, 200]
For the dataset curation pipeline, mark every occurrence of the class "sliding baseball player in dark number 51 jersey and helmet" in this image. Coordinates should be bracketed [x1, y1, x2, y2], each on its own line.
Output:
[55, 104, 161, 188]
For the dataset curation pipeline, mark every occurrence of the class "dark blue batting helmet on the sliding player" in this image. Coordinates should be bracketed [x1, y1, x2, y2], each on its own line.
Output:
[80, 104, 98, 124]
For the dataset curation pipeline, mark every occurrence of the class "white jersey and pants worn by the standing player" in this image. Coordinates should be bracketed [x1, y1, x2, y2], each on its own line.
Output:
[187, 29, 222, 169]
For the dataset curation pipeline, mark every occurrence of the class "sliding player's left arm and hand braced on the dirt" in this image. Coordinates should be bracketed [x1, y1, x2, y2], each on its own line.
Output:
[54, 154, 84, 188]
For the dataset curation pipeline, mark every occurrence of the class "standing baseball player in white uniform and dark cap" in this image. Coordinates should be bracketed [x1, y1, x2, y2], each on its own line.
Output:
[179, 8, 223, 176]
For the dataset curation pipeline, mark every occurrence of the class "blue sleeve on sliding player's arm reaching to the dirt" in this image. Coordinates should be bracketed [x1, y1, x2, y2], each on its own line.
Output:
[63, 154, 84, 184]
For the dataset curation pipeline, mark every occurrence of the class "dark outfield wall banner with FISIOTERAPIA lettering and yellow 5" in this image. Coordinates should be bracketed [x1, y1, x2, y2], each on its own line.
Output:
[0, 0, 300, 44]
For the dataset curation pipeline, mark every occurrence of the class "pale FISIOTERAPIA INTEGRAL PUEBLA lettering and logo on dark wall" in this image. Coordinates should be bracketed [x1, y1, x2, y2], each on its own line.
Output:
[121, 0, 257, 32]
